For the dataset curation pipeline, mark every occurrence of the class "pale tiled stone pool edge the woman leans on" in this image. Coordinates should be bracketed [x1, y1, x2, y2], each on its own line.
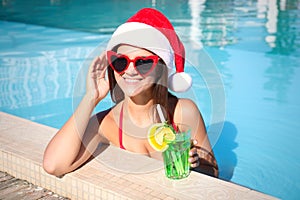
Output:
[0, 112, 275, 200]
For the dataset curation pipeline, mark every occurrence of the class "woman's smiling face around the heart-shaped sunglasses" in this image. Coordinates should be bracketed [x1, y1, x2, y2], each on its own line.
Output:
[114, 45, 163, 97]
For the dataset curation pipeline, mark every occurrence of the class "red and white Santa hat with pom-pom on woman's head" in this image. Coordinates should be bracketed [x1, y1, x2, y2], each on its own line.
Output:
[107, 8, 192, 92]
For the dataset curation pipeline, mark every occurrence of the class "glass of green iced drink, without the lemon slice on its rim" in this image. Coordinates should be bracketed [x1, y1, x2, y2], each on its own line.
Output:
[162, 124, 191, 179]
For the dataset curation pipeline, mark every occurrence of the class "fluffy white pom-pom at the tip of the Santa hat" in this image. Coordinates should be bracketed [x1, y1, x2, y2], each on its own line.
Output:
[168, 72, 192, 92]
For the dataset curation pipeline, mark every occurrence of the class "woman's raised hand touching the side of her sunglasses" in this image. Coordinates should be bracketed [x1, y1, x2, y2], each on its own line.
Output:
[86, 52, 109, 106]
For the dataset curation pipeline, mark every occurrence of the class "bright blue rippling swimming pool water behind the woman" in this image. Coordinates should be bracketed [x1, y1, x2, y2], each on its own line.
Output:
[0, 0, 300, 199]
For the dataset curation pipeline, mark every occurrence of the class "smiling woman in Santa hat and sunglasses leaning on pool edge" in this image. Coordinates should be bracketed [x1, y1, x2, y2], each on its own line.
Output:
[43, 8, 218, 177]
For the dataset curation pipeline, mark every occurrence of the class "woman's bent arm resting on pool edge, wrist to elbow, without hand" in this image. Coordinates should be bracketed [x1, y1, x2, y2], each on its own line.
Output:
[43, 96, 101, 176]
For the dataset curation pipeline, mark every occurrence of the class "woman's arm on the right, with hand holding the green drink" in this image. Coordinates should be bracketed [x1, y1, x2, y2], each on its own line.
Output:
[174, 99, 218, 177]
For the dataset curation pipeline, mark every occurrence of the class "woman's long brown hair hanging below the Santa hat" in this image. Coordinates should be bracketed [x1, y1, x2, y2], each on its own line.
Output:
[107, 48, 178, 123]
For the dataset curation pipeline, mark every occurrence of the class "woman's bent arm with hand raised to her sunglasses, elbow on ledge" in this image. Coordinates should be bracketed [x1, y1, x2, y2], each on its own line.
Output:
[43, 54, 109, 176]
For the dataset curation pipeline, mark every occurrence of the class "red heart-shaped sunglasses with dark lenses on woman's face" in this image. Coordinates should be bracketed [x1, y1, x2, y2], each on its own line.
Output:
[107, 51, 159, 77]
